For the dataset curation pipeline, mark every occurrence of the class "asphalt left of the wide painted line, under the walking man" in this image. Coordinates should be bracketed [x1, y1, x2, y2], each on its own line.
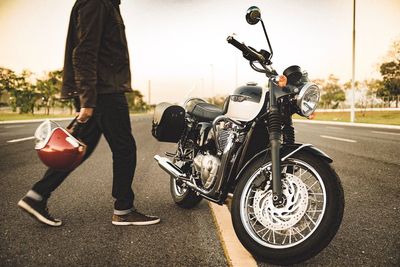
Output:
[0, 117, 226, 267]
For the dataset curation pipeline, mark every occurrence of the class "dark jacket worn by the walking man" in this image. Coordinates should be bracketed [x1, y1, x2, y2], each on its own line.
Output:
[61, 0, 132, 108]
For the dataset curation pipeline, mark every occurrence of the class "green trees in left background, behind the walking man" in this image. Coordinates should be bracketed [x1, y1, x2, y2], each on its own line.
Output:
[0, 67, 149, 115]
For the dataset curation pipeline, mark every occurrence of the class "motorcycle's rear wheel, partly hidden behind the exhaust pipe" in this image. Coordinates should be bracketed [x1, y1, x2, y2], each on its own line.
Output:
[170, 147, 203, 209]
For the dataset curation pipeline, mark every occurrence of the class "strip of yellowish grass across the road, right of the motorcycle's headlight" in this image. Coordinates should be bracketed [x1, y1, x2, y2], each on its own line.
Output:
[293, 111, 400, 125]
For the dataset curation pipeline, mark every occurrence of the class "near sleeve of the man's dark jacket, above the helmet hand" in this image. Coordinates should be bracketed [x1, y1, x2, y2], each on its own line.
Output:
[72, 0, 106, 108]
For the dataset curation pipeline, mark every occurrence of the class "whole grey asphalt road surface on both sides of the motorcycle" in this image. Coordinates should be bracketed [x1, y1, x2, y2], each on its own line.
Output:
[0, 117, 400, 266]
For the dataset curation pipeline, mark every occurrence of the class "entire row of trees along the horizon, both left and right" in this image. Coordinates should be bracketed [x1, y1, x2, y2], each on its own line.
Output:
[0, 40, 400, 114]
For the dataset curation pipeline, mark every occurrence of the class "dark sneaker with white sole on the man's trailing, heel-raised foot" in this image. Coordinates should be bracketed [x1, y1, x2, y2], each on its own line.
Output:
[18, 196, 62, 226]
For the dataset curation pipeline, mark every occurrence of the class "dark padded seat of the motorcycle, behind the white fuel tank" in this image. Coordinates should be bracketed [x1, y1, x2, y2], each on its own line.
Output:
[186, 98, 223, 121]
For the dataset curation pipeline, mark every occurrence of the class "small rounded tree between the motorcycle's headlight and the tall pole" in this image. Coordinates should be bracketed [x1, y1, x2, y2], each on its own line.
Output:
[321, 74, 346, 109]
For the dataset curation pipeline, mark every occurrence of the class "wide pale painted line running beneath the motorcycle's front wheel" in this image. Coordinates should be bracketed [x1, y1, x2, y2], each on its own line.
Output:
[208, 202, 257, 267]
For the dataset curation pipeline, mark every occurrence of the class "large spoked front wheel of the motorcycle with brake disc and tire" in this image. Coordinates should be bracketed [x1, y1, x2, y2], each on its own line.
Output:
[231, 152, 344, 265]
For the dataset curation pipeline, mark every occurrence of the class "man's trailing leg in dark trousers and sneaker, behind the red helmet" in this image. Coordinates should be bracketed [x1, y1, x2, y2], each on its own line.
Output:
[18, 116, 101, 226]
